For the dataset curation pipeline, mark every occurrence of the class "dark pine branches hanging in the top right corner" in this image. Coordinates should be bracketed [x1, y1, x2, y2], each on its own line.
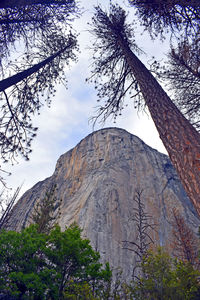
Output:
[129, 0, 200, 38]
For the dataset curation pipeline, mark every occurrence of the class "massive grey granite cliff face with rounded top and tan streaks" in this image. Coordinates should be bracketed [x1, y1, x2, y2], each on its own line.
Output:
[9, 128, 200, 279]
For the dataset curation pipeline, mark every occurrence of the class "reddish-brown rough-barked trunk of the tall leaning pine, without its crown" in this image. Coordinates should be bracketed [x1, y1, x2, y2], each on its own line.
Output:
[118, 36, 200, 216]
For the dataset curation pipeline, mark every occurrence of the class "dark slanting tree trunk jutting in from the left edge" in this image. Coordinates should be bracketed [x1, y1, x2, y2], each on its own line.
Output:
[0, 41, 73, 92]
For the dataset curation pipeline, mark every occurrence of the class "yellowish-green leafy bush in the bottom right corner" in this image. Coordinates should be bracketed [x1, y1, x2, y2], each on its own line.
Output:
[133, 248, 200, 300]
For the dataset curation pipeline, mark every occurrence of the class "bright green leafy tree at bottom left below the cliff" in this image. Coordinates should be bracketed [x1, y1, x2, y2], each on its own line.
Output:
[0, 224, 111, 299]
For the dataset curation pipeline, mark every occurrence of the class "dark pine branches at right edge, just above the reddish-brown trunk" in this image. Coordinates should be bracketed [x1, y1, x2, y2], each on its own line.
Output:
[156, 38, 200, 130]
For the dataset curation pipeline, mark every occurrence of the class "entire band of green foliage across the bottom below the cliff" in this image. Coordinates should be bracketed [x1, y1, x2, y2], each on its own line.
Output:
[0, 224, 200, 300]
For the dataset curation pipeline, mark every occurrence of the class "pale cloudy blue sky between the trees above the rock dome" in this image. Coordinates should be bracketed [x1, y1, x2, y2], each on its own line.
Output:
[2, 0, 168, 194]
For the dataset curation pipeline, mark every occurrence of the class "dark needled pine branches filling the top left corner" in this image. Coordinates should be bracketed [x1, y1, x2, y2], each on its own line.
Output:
[0, 0, 79, 59]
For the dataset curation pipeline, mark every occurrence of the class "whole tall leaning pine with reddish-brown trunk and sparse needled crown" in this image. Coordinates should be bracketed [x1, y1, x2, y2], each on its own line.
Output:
[90, 5, 200, 215]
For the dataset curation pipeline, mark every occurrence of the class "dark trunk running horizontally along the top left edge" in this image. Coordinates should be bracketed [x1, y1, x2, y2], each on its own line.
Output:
[0, 0, 74, 8]
